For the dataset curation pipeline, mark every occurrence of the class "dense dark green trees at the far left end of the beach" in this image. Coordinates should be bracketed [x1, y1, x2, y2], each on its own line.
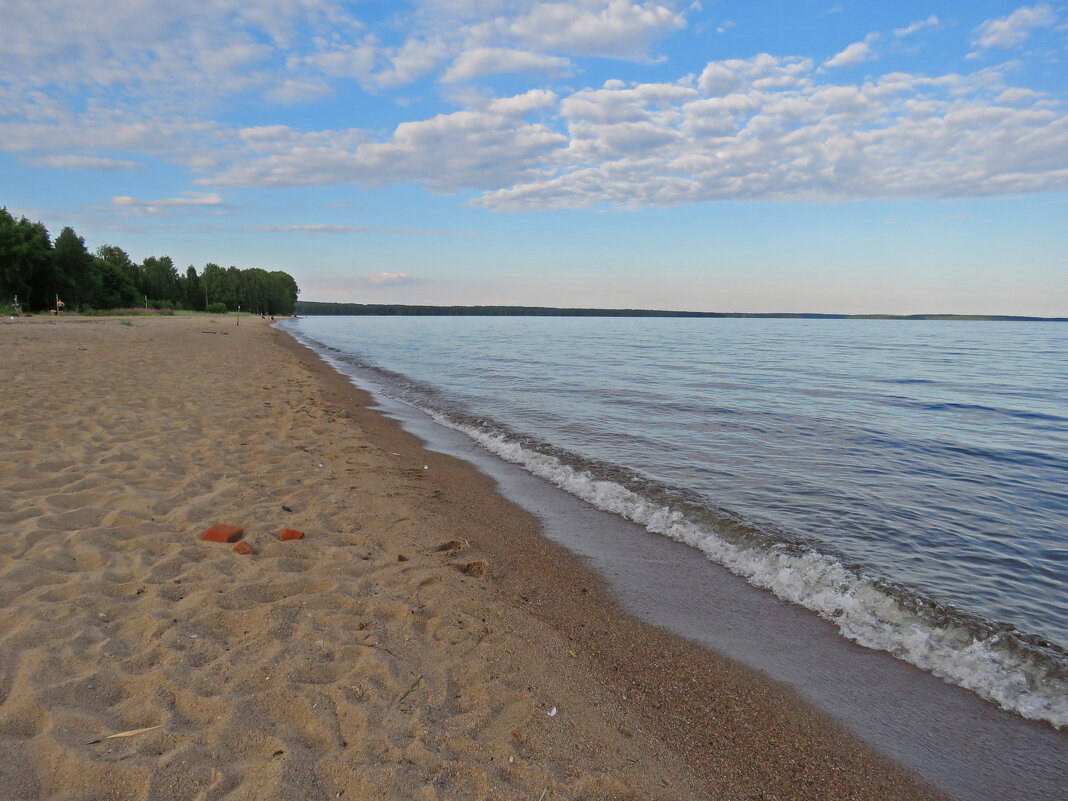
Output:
[0, 208, 299, 314]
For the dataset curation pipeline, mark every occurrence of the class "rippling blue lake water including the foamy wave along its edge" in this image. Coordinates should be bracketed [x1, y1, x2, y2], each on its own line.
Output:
[289, 317, 1068, 727]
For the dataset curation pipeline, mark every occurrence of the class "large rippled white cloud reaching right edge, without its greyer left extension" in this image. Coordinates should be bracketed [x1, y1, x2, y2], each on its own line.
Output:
[477, 62, 1068, 210]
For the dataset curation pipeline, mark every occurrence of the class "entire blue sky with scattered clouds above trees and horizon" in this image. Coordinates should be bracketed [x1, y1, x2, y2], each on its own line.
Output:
[0, 0, 1068, 316]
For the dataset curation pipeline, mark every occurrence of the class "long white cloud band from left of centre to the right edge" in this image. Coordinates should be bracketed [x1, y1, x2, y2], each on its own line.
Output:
[192, 54, 1068, 209]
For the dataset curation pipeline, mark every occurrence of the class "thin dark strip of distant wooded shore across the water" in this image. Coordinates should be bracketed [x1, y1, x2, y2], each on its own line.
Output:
[294, 300, 1068, 323]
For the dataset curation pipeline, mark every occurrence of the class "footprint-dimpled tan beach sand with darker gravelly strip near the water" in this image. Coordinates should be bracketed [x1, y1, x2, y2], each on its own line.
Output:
[0, 316, 952, 801]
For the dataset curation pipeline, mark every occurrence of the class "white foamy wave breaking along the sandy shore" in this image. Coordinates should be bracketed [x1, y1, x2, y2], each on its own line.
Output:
[286, 326, 1068, 728]
